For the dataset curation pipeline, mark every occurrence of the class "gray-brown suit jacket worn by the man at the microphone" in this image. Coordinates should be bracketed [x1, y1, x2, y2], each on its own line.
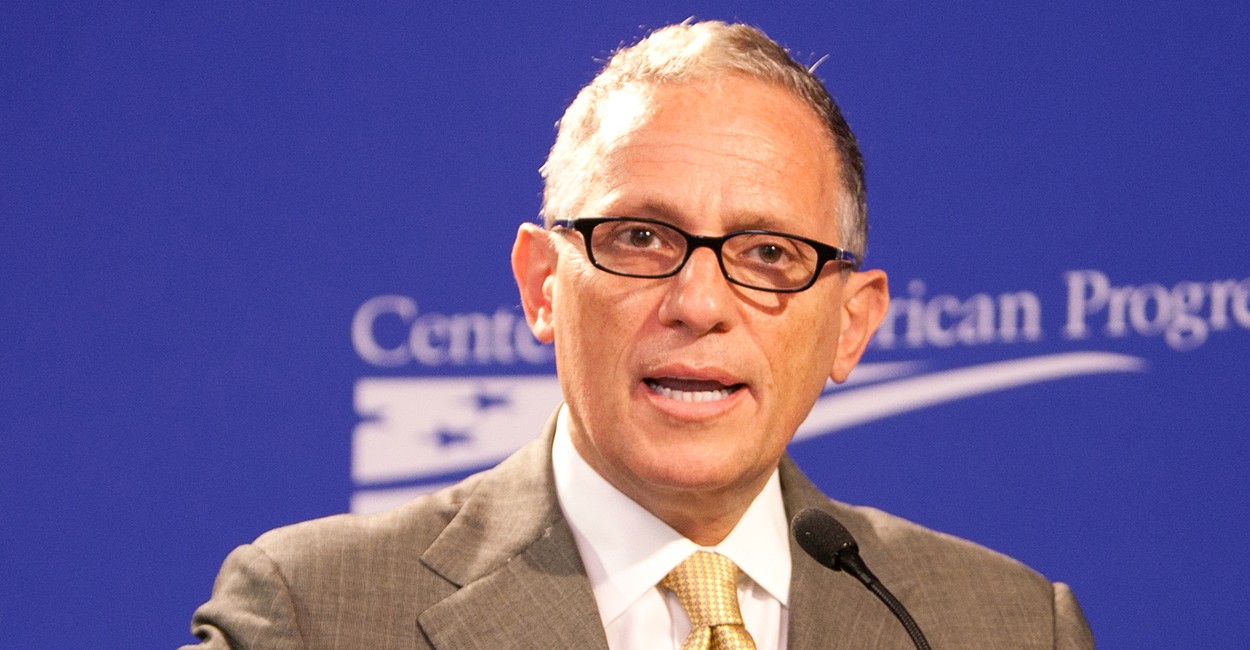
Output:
[186, 430, 1094, 650]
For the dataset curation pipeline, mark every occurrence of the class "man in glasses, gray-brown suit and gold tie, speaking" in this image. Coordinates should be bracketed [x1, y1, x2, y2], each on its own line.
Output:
[182, 23, 1093, 650]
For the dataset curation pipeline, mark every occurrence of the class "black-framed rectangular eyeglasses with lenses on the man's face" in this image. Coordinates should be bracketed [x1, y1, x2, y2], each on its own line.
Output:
[551, 216, 859, 294]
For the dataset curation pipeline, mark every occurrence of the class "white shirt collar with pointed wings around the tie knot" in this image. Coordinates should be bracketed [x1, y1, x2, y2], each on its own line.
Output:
[551, 406, 790, 625]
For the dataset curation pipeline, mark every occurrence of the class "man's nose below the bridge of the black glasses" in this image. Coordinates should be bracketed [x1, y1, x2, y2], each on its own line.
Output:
[660, 248, 739, 335]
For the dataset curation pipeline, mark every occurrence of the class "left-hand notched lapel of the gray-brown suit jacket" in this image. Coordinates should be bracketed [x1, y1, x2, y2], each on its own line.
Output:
[418, 421, 608, 650]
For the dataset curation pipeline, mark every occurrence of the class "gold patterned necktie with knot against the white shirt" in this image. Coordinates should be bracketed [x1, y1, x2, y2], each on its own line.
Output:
[660, 551, 755, 650]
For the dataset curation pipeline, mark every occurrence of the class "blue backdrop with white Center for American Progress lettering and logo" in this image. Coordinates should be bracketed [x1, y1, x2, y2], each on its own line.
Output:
[0, 1, 1250, 649]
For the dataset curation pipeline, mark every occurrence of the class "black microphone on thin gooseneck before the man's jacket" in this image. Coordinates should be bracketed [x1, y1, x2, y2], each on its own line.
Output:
[790, 508, 929, 650]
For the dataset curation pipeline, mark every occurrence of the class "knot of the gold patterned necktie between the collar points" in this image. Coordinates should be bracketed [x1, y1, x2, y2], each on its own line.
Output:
[660, 551, 743, 628]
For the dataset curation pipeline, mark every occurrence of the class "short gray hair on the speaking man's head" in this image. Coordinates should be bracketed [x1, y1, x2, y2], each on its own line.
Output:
[540, 21, 868, 259]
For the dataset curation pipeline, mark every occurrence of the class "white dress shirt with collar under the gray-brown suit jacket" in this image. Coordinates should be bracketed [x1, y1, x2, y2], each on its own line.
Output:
[551, 408, 790, 650]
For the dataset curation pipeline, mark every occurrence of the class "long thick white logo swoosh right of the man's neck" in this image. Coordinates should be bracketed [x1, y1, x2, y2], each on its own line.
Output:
[794, 353, 1146, 440]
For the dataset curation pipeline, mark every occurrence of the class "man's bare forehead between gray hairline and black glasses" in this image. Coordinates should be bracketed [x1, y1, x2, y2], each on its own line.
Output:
[584, 76, 841, 240]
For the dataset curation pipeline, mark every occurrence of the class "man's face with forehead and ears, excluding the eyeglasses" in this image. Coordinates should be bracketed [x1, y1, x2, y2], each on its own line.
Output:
[514, 78, 884, 522]
